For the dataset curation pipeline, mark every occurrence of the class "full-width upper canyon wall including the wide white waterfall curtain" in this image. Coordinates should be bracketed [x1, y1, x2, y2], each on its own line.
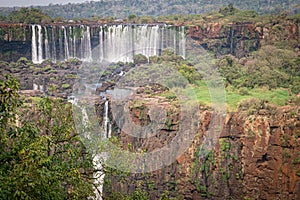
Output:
[0, 21, 299, 63]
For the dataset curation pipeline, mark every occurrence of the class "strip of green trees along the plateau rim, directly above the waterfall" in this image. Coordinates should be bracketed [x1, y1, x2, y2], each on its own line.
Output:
[0, 3, 300, 26]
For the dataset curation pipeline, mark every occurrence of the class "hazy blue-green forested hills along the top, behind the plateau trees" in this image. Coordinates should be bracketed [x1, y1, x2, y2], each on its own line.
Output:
[0, 0, 300, 19]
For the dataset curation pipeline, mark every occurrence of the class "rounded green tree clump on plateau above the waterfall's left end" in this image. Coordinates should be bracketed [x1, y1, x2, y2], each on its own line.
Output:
[7, 8, 51, 24]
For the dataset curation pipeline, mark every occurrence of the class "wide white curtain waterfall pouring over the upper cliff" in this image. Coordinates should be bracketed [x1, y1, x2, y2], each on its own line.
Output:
[31, 25, 185, 63]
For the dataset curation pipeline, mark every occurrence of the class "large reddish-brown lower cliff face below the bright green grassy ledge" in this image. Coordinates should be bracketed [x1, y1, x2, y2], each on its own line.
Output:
[105, 103, 300, 200]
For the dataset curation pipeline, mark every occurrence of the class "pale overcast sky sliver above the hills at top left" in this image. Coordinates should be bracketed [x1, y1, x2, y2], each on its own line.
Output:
[0, 0, 91, 7]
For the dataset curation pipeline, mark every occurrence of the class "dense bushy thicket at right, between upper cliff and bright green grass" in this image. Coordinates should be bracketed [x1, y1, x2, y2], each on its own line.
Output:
[217, 45, 300, 95]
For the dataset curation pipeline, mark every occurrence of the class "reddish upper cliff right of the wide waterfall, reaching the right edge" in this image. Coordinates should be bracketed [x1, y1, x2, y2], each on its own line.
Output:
[187, 21, 300, 58]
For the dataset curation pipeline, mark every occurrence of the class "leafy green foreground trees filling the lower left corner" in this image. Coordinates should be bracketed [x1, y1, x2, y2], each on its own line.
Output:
[0, 77, 93, 199]
